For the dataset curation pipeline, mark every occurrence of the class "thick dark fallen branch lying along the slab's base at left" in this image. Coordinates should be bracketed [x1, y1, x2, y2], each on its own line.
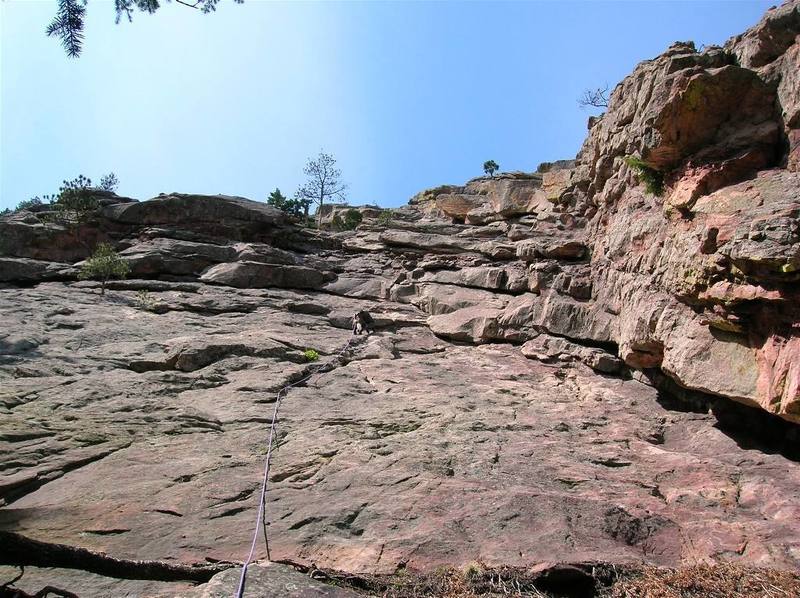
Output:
[0, 531, 238, 583]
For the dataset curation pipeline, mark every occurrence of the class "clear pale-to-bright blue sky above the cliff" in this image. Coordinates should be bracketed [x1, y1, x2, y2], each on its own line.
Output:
[0, 0, 776, 209]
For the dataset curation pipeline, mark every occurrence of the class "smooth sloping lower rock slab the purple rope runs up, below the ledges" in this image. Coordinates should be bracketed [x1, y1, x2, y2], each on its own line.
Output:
[0, 281, 800, 594]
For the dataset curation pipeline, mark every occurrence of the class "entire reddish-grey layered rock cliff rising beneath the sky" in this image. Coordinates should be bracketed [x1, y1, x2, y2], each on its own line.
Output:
[0, 1, 800, 596]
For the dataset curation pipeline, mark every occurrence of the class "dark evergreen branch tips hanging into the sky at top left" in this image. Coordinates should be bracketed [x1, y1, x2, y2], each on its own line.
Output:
[46, 0, 244, 58]
